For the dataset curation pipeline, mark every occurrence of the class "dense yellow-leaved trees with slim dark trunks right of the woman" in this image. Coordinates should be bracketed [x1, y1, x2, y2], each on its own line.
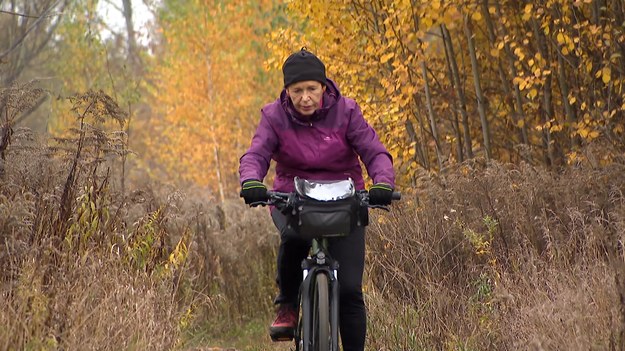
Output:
[272, 0, 625, 184]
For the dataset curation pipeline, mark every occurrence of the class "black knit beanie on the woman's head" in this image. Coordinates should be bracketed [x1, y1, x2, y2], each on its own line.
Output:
[282, 47, 327, 88]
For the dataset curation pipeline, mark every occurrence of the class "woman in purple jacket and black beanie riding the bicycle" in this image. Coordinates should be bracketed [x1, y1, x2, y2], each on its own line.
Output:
[239, 48, 395, 351]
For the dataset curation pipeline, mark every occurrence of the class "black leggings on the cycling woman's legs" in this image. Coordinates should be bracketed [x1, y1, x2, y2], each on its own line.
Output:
[271, 209, 367, 351]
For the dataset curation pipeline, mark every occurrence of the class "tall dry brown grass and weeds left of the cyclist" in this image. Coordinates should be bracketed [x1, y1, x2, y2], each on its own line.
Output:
[0, 91, 276, 350]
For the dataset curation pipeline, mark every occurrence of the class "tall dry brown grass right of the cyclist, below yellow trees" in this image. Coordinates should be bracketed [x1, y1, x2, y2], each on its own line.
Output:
[368, 164, 625, 350]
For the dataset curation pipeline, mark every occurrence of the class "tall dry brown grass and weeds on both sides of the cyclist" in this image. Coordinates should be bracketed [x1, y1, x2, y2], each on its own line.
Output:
[0, 86, 625, 350]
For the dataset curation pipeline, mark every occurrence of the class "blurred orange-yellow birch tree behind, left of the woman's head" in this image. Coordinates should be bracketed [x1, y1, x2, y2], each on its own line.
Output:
[147, 0, 280, 201]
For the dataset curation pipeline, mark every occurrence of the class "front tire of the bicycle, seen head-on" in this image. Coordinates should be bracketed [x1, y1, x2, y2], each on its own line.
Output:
[312, 274, 331, 351]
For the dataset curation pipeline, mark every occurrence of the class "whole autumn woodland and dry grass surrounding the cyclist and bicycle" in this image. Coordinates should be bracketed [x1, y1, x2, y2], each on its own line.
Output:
[0, 0, 625, 350]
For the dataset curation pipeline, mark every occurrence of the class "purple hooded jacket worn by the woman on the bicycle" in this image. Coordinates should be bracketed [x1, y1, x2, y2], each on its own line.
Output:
[239, 79, 395, 192]
